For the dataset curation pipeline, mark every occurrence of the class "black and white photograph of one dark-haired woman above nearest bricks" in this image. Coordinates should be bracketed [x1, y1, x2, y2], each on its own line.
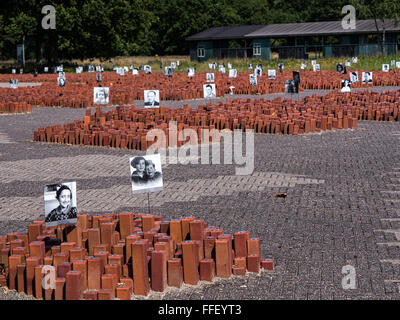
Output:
[44, 182, 78, 227]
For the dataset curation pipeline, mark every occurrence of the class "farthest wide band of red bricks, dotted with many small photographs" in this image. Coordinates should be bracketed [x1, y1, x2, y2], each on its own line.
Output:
[0, 70, 400, 108]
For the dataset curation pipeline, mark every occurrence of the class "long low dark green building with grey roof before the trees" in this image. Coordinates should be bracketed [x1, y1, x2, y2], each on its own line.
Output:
[186, 20, 400, 61]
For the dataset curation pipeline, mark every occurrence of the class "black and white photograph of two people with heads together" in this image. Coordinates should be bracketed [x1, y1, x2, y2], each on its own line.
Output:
[129, 154, 163, 194]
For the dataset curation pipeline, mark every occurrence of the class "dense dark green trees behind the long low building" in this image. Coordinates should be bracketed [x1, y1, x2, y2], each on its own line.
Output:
[0, 0, 400, 61]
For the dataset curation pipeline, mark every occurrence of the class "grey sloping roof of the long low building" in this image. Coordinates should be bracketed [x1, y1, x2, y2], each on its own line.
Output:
[186, 20, 400, 41]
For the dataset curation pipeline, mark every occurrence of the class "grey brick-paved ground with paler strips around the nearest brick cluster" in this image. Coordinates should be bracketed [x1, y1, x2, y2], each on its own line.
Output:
[0, 86, 400, 300]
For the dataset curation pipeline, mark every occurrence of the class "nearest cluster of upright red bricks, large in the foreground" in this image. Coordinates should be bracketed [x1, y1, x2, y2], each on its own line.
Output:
[0, 212, 273, 300]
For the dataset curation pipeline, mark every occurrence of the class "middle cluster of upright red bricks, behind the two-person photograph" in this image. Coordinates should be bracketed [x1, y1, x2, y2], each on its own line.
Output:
[34, 91, 400, 150]
